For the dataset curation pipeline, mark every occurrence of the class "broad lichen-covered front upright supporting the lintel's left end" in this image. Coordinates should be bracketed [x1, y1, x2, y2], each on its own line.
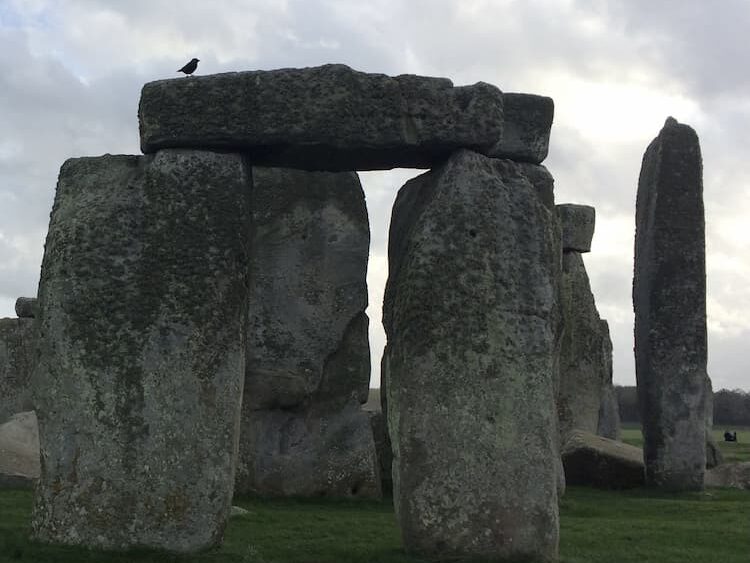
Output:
[32, 150, 250, 552]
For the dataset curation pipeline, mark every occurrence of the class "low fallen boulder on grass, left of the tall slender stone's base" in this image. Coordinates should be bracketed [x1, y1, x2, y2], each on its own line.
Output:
[562, 430, 644, 489]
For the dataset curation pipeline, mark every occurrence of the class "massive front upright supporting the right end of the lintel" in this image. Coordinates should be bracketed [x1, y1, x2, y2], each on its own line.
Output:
[383, 151, 560, 561]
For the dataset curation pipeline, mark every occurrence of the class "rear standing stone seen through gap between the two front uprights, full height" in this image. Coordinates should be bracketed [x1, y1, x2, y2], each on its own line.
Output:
[235, 168, 380, 497]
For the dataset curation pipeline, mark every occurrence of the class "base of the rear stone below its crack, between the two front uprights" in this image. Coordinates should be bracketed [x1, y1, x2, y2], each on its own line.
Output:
[237, 405, 381, 498]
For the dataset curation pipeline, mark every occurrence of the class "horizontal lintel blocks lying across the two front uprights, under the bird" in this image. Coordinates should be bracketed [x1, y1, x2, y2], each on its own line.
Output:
[139, 65, 553, 171]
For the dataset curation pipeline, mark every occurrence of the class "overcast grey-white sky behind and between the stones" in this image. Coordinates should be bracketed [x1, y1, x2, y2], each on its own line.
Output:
[0, 0, 750, 389]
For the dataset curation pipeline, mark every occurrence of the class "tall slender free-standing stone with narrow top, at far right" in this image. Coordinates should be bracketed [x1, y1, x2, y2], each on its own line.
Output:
[633, 118, 708, 490]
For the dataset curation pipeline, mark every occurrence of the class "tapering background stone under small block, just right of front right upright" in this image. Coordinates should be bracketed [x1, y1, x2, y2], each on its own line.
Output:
[557, 252, 612, 439]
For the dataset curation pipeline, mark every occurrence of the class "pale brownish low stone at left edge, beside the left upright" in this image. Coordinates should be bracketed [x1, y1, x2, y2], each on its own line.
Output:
[0, 411, 39, 489]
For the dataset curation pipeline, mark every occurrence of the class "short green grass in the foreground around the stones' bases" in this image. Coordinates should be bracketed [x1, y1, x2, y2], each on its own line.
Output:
[0, 488, 750, 563]
